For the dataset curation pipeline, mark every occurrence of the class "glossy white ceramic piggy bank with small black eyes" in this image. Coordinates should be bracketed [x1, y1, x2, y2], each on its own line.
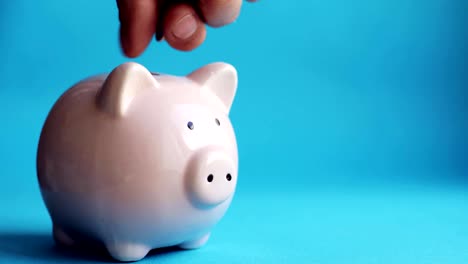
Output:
[37, 62, 238, 261]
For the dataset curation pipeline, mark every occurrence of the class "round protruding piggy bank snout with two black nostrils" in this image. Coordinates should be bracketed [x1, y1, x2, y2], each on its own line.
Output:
[186, 148, 237, 207]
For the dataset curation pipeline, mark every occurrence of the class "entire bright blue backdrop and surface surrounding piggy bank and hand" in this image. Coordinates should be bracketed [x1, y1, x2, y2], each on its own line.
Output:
[0, 0, 468, 264]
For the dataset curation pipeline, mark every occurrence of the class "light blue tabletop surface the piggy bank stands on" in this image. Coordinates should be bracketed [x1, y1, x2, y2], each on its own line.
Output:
[0, 184, 468, 263]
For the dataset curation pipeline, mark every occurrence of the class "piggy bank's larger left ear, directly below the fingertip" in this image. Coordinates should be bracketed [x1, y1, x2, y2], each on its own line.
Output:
[97, 62, 159, 117]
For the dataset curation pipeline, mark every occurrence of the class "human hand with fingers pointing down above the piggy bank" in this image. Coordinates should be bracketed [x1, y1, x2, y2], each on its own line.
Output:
[117, 0, 256, 58]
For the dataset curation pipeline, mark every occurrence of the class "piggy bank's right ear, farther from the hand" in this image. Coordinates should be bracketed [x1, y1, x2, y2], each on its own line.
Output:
[188, 62, 237, 113]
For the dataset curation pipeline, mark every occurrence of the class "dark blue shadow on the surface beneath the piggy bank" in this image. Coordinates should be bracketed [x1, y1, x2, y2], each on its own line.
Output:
[0, 232, 186, 263]
